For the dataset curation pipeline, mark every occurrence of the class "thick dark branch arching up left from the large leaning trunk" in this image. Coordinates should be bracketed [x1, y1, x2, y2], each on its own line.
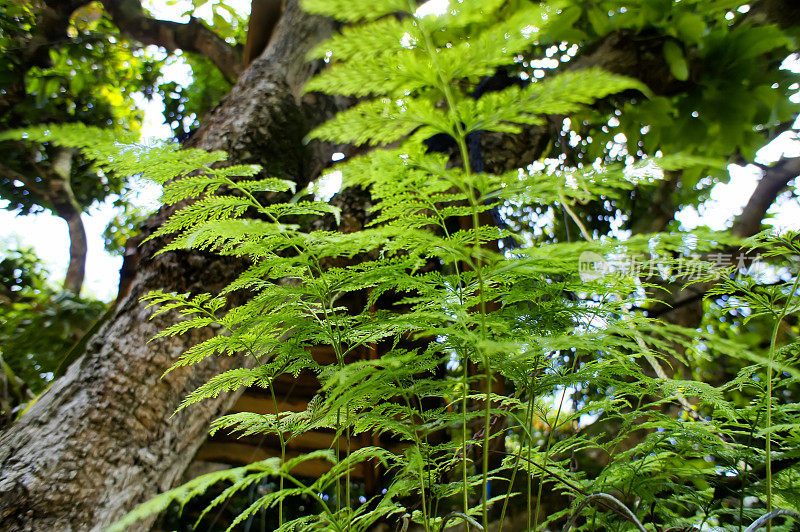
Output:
[103, 0, 242, 82]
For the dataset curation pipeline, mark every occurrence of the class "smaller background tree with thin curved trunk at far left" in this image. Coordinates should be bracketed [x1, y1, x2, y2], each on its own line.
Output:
[0, 0, 166, 295]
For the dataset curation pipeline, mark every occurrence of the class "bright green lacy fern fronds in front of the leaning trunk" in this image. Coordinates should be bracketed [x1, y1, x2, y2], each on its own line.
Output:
[10, 0, 798, 530]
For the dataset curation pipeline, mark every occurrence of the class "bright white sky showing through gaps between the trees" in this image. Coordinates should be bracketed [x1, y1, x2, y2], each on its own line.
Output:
[0, 0, 800, 301]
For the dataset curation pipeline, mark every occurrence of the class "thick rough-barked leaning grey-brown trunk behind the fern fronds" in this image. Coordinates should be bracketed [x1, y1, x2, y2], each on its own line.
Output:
[0, 2, 335, 531]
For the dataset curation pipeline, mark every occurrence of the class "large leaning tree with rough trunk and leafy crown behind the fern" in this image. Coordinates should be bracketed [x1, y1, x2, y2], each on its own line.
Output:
[0, 1, 800, 529]
